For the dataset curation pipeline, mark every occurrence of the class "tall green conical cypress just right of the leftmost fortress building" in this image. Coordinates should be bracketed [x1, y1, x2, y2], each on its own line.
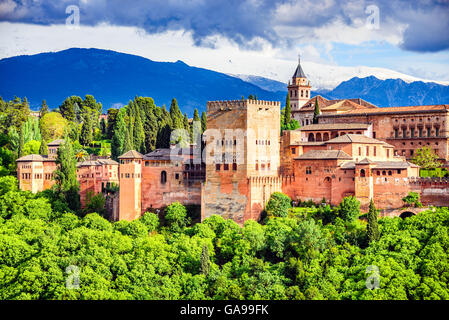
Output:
[55, 135, 81, 212]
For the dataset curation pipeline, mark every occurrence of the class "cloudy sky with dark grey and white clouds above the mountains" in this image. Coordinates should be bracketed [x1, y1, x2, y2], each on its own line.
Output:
[0, 0, 449, 81]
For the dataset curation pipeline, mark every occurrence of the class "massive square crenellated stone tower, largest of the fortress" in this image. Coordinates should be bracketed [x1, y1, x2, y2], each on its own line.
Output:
[201, 100, 281, 224]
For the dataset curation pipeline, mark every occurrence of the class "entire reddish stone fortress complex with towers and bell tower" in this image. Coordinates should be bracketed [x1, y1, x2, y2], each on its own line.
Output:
[17, 63, 449, 224]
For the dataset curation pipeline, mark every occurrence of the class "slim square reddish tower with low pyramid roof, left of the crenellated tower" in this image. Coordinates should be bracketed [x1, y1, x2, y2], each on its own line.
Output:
[118, 150, 143, 221]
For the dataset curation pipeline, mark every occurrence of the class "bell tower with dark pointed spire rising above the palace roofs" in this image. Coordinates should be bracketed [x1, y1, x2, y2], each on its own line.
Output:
[288, 57, 312, 112]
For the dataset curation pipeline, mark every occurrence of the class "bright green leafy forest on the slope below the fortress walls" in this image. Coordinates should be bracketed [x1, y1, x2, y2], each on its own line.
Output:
[0, 177, 449, 299]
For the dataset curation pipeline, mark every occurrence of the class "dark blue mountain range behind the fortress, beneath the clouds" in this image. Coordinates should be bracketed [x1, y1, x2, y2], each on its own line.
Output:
[0, 48, 449, 116]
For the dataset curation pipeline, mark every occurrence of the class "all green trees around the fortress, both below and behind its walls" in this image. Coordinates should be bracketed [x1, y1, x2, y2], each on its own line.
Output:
[0, 96, 449, 300]
